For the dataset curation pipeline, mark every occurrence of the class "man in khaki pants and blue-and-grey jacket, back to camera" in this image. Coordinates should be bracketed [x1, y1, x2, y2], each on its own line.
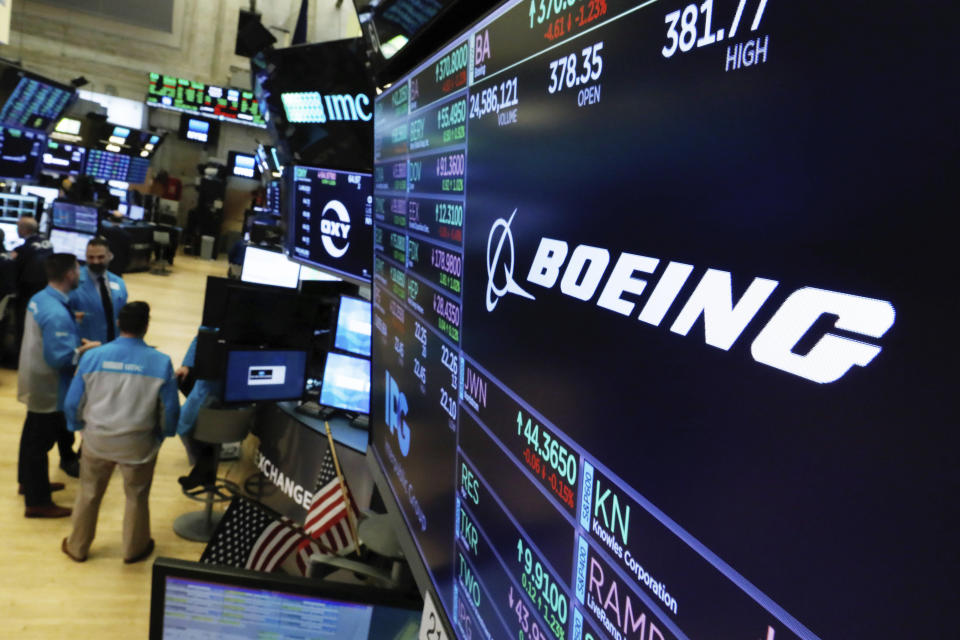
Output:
[61, 302, 180, 563]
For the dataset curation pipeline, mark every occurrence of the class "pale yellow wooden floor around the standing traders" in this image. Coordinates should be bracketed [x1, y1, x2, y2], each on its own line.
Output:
[0, 256, 242, 640]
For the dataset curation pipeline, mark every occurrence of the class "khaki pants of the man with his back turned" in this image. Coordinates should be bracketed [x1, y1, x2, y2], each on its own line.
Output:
[67, 448, 157, 559]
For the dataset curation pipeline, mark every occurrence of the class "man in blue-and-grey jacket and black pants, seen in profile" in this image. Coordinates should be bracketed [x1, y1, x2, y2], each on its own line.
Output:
[17, 253, 99, 518]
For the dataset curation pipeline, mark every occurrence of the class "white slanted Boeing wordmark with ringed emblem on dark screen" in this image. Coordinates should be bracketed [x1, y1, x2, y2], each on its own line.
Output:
[486, 218, 896, 384]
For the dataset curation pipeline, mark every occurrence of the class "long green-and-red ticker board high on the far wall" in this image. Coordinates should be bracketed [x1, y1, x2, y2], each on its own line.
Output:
[146, 73, 266, 127]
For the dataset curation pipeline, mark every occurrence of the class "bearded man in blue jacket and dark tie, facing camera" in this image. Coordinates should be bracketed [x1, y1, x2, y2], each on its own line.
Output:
[70, 237, 127, 344]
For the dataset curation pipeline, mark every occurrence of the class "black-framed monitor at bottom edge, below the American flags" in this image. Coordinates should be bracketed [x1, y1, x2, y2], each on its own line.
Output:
[150, 558, 423, 640]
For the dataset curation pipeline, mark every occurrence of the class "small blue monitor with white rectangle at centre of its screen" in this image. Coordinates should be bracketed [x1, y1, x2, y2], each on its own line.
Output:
[223, 350, 307, 403]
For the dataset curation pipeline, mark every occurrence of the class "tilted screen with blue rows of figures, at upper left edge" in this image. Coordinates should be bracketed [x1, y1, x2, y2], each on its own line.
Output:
[0, 62, 76, 130]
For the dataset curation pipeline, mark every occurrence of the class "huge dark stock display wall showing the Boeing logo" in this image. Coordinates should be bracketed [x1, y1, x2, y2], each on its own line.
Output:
[371, 0, 958, 640]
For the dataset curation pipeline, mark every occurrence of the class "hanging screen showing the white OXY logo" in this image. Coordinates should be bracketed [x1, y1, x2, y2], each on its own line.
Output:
[287, 166, 373, 282]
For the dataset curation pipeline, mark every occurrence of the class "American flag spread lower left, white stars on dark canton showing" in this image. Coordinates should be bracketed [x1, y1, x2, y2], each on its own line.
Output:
[200, 496, 304, 572]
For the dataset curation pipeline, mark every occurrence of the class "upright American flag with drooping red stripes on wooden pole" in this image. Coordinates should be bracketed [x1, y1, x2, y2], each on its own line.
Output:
[303, 446, 356, 553]
